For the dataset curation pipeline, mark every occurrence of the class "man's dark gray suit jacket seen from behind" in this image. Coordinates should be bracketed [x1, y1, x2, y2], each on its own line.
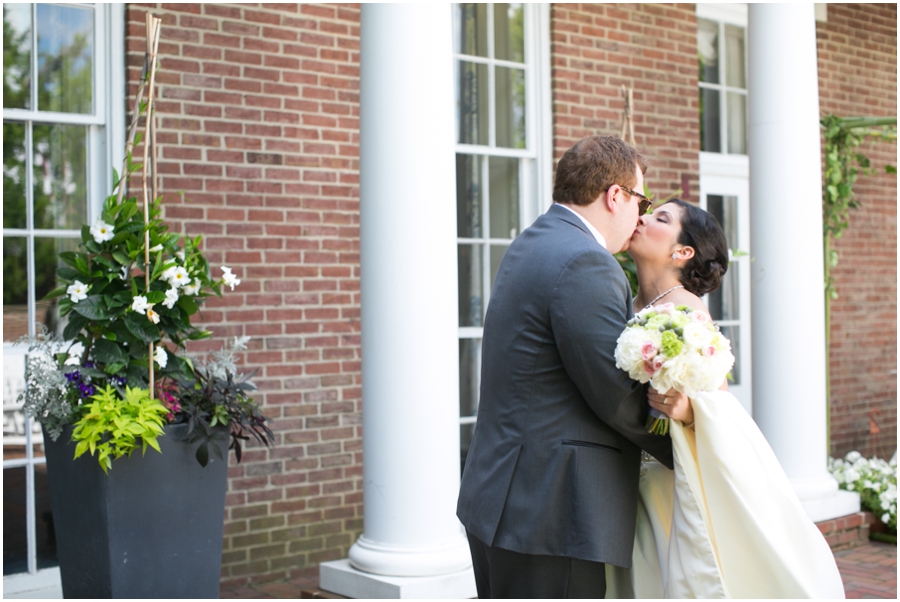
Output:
[457, 204, 672, 567]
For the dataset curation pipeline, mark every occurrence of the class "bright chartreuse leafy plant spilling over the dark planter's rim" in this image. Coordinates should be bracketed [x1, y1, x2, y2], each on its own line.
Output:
[72, 385, 169, 472]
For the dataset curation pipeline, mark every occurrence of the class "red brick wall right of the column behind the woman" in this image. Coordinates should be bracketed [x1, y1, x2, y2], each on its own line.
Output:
[817, 4, 897, 457]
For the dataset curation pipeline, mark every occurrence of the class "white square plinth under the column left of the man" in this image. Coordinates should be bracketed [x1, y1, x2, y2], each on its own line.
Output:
[319, 558, 478, 599]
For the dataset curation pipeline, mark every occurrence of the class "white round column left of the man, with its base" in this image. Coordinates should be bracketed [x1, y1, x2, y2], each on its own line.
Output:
[320, 3, 476, 598]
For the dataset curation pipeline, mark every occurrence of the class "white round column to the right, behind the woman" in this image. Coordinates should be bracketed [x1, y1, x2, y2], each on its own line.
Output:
[748, 4, 859, 521]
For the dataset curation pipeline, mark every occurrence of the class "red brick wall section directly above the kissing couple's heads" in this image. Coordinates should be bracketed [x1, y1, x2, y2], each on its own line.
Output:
[550, 4, 700, 202]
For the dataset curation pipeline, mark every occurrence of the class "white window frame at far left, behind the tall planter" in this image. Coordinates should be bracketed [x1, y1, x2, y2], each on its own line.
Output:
[3, 4, 126, 584]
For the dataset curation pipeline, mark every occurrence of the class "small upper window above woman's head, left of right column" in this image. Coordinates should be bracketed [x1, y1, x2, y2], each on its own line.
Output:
[697, 5, 747, 155]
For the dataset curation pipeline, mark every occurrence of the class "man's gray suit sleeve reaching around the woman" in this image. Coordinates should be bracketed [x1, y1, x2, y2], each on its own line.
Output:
[550, 249, 673, 468]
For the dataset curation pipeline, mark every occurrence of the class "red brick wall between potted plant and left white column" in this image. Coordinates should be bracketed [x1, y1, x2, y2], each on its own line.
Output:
[126, 4, 362, 583]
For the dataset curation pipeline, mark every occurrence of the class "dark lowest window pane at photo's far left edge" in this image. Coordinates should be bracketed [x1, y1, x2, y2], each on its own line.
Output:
[3, 464, 28, 575]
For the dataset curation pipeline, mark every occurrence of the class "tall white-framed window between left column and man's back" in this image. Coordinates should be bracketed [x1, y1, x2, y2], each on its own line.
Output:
[453, 3, 551, 460]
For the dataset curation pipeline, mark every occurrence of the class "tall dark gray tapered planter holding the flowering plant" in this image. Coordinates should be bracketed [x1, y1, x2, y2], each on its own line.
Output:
[44, 424, 228, 598]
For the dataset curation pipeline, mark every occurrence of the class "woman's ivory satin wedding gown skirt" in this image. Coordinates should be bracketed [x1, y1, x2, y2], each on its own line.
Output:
[606, 391, 844, 598]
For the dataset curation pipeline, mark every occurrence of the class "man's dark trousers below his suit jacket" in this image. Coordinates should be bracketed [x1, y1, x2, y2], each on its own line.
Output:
[466, 531, 606, 599]
